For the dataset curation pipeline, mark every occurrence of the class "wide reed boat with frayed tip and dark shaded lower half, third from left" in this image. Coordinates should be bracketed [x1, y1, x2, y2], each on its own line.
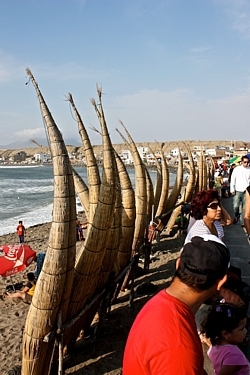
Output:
[65, 89, 117, 344]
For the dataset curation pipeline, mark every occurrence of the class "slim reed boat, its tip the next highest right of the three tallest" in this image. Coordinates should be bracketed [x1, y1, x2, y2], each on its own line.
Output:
[116, 121, 147, 255]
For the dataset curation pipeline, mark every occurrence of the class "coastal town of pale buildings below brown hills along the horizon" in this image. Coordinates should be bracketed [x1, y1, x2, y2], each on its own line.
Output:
[0, 141, 250, 167]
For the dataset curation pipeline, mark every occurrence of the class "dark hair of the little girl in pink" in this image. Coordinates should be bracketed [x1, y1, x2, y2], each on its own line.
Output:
[202, 303, 246, 345]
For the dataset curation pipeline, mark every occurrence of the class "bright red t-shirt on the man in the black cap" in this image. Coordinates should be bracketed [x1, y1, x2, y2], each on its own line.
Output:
[123, 290, 204, 375]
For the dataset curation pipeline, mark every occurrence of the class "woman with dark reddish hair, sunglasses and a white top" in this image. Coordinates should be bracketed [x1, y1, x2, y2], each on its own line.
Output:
[185, 189, 229, 243]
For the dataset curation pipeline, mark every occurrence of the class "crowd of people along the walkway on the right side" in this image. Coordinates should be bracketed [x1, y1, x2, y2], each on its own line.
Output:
[122, 156, 250, 375]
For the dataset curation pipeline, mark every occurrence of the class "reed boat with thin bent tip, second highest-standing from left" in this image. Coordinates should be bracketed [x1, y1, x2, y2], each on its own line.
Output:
[68, 93, 101, 222]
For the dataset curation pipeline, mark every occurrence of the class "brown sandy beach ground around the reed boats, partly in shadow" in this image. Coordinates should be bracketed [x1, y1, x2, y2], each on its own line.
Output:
[0, 215, 185, 375]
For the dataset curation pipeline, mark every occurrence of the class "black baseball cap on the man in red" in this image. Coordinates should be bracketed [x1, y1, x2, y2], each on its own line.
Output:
[180, 234, 230, 281]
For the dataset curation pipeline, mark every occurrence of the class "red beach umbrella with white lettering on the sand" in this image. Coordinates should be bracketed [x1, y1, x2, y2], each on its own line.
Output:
[0, 244, 36, 277]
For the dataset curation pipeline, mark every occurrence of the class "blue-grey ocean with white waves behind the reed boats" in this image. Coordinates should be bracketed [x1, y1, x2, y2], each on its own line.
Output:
[0, 165, 175, 235]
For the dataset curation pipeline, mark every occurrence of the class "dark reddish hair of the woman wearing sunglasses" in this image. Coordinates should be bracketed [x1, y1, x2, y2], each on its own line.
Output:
[191, 189, 220, 220]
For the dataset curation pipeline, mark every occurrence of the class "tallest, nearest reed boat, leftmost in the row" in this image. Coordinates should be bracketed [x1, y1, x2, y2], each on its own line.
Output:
[22, 69, 76, 375]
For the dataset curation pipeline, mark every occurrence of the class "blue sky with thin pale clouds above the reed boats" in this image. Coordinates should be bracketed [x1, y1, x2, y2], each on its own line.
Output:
[0, 0, 250, 145]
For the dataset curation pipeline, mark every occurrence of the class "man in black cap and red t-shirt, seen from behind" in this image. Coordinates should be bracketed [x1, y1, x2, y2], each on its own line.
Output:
[123, 235, 230, 375]
